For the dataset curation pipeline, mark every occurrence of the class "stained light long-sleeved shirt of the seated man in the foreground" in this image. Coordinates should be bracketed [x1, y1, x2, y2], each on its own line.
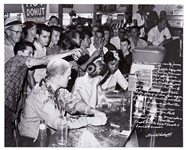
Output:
[18, 84, 91, 138]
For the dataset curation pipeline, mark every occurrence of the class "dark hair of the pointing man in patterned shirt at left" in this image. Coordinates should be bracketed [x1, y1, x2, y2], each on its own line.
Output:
[14, 40, 36, 55]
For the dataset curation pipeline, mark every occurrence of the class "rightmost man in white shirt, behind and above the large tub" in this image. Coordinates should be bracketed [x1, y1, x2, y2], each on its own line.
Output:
[147, 18, 172, 46]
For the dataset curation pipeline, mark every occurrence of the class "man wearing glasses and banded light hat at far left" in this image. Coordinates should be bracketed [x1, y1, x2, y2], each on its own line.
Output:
[4, 17, 22, 63]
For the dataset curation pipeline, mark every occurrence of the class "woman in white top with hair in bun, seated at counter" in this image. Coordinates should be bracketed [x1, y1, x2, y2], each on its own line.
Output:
[72, 60, 108, 108]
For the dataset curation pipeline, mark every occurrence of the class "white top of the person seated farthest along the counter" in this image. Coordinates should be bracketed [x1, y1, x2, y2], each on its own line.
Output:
[102, 69, 128, 91]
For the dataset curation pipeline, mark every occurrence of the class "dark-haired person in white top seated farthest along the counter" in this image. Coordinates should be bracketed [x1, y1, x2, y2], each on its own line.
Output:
[100, 50, 128, 92]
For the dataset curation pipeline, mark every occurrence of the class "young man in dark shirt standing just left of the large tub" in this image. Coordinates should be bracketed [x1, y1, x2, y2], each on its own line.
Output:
[118, 38, 132, 74]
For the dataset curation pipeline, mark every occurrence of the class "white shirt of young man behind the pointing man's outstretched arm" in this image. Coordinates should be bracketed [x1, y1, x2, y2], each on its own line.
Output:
[34, 41, 46, 82]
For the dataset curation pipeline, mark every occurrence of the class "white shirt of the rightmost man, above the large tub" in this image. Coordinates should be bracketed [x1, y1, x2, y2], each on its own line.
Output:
[147, 26, 171, 46]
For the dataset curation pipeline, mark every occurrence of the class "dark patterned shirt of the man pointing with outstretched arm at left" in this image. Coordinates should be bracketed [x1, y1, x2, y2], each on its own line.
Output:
[5, 55, 29, 112]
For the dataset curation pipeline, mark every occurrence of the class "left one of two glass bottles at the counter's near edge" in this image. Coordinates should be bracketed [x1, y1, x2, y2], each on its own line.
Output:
[36, 120, 49, 147]
